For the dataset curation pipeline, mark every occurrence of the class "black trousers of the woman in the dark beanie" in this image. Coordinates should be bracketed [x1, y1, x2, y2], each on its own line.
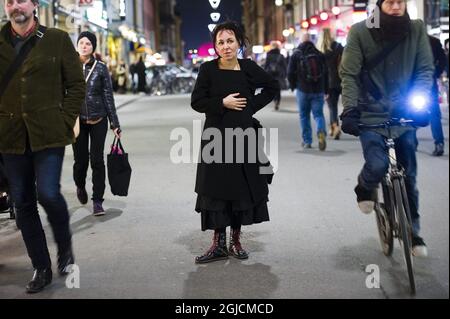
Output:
[72, 118, 108, 201]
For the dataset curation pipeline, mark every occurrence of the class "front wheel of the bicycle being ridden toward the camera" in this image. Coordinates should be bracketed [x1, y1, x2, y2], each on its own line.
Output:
[392, 179, 416, 294]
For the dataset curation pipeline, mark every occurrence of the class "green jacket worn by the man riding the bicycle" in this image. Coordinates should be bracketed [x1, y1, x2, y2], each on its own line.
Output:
[339, 20, 434, 136]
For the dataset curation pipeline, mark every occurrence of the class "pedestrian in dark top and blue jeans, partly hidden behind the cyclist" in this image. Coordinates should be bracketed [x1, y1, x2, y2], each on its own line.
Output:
[428, 35, 448, 156]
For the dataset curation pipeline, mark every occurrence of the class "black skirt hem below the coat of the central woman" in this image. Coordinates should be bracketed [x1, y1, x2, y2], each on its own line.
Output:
[195, 195, 269, 231]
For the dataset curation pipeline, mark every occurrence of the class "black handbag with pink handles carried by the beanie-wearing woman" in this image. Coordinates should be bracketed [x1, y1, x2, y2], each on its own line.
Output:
[107, 137, 132, 196]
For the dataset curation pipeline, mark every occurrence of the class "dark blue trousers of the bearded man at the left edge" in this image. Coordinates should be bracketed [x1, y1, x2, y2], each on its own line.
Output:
[3, 147, 72, 269]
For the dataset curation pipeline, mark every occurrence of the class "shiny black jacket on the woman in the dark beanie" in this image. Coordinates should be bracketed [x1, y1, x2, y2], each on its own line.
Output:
[80, 58, 120, 128]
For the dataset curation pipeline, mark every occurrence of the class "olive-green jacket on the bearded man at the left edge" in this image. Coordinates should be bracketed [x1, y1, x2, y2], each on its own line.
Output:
[0, 23, 85, 154]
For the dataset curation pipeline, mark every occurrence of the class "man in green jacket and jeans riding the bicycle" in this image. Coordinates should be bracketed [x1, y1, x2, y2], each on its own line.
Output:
[340, 0, 434, 256]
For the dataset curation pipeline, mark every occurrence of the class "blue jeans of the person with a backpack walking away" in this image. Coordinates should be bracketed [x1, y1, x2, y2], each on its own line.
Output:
[296, 89, 326, 144]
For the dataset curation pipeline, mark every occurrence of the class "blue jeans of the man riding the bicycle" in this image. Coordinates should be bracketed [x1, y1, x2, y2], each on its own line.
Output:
[358, 130, 420, 236]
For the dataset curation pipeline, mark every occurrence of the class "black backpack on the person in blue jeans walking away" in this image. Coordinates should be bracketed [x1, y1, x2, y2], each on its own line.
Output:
[298, 48, 325, 84]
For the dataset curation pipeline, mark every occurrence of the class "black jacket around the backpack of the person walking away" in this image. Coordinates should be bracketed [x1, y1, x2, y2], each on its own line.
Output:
[288, 41, 328, 94]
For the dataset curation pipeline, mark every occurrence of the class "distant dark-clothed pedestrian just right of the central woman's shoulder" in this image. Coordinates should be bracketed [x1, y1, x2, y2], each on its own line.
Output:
[264, 41, 287, 110]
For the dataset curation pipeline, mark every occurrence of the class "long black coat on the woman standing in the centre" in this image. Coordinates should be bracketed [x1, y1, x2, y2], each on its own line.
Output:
[191, 59, 279, 201]
